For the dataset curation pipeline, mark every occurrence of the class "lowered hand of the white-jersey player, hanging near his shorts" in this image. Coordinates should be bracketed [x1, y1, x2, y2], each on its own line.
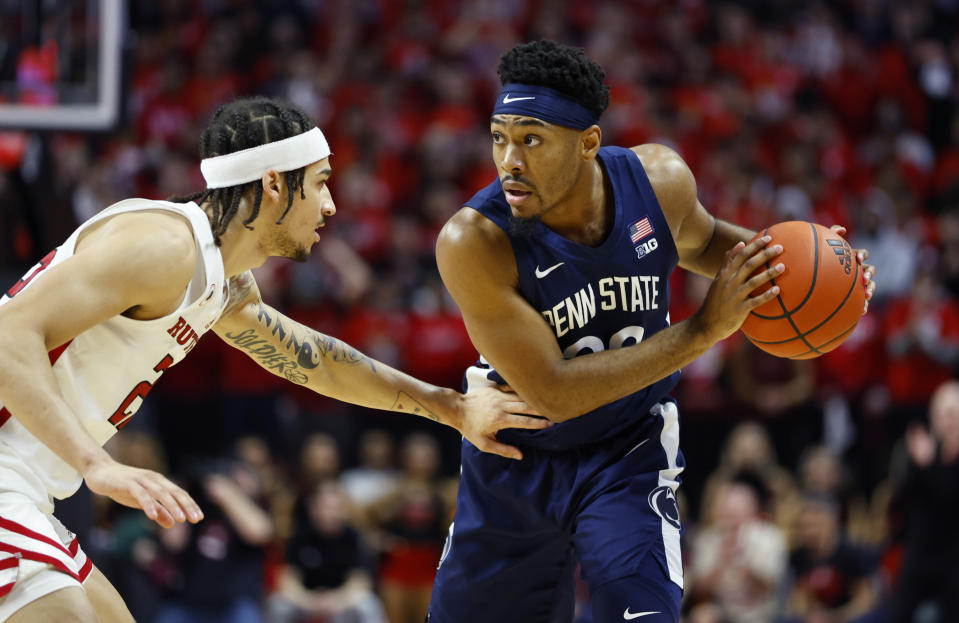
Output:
[83, 461, 203, 528]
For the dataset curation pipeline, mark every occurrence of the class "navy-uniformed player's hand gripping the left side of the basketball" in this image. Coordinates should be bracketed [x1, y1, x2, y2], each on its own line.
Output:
[694, 236, 785, 342]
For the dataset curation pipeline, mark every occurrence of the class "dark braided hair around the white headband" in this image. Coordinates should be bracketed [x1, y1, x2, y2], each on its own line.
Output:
[170, 97, 316, 246]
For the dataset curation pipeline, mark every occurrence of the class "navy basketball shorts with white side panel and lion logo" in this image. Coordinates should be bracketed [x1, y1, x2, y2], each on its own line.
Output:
[427, 402, 685, 623]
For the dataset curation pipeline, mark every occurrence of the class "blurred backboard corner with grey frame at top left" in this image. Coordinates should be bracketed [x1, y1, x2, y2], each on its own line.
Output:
[0, 0, 126, 130]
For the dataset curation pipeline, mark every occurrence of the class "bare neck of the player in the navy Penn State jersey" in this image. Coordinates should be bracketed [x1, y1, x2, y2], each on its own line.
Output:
[543, 159, 614, 247]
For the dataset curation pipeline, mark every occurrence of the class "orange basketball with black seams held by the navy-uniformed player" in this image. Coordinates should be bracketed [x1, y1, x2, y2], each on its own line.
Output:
[742, 221, 866, 359]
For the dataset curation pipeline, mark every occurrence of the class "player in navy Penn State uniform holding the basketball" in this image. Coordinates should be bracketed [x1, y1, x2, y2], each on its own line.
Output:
[429, 41, 875, 623]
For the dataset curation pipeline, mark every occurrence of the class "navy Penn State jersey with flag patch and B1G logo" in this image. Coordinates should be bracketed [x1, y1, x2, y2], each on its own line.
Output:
[464, 147, 679, 450]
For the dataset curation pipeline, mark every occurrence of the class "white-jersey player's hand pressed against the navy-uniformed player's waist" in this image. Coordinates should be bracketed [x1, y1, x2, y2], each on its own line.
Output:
[458, 385, 553, 460]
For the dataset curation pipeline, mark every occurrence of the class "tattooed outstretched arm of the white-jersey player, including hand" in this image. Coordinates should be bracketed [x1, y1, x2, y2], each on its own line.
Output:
[214, 272, 549, 458]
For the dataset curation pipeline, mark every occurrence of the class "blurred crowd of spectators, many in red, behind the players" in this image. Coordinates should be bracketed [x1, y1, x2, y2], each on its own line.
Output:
[0, 0, 959, 623]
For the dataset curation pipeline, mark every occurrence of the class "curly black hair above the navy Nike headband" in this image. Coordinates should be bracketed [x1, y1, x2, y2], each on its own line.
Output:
[496, 39, 609, 119]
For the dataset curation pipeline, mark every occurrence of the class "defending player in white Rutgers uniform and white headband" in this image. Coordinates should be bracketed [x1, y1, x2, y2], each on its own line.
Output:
[0, 98, 548, 623]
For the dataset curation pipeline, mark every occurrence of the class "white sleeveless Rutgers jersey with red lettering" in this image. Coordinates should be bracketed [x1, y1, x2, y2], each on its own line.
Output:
[0, 199, 227, 512]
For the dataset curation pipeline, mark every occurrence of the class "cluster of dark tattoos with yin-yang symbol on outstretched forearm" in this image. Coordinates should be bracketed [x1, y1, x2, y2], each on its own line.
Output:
[224, 305, 376, 385]
